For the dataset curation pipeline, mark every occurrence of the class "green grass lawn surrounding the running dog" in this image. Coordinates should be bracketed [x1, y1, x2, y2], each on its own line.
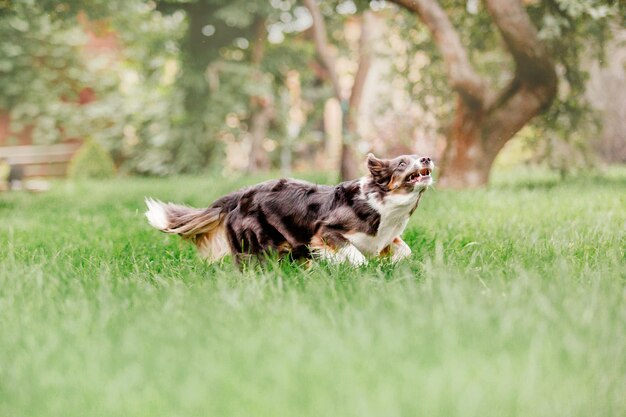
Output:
[0, 170, 626, 417]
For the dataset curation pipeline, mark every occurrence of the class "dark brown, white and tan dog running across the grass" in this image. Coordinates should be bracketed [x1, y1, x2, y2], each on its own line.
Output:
[145, 154, 434, 266]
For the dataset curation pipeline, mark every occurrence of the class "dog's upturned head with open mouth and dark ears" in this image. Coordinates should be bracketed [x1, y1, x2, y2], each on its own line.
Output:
[367, 153, 435, 194]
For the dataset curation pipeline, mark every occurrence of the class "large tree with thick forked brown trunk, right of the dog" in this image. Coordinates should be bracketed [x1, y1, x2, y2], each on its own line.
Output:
[392, 0, 609, 188]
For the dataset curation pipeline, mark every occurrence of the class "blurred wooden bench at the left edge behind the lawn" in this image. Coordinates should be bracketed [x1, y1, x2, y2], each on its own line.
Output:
[0, 142, 81, 178]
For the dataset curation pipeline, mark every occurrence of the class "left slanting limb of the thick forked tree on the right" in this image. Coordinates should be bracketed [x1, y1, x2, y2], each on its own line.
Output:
[391, 0, 488, 106]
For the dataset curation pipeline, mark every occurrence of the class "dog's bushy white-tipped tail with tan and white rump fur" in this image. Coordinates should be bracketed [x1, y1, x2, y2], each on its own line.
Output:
[146, 198, 229, 260]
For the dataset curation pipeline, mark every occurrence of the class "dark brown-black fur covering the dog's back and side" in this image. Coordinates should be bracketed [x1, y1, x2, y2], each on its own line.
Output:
[211, 179, 380, 257]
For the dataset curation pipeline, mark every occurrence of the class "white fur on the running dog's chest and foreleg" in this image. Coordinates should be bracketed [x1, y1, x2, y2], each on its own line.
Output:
[346, 194, 419, 255]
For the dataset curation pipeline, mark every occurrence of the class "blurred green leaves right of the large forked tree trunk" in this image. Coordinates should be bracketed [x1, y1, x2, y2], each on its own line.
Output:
[528, 0, 619, 172]
